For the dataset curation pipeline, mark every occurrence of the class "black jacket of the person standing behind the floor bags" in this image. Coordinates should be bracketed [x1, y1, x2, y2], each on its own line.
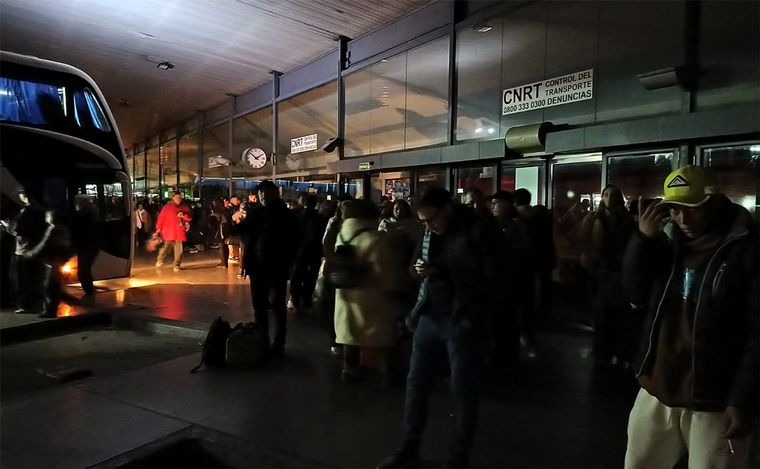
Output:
[232, 199, 301, 280]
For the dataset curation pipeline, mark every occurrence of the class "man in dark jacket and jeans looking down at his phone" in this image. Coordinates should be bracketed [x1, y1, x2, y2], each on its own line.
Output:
[378, 187, 497, 467]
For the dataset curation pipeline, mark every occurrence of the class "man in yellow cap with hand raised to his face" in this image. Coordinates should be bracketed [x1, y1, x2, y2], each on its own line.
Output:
[623, 166, 760, 468]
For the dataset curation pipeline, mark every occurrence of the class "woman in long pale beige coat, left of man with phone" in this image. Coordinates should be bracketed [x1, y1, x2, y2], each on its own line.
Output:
[335, 200, 408, 384]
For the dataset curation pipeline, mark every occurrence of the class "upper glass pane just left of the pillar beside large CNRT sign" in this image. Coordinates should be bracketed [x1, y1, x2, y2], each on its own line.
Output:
[405, 36, 449, 149]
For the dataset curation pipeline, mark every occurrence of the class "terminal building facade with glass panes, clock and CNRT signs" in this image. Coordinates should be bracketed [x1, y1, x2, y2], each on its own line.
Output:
[121, 1, 760, 325]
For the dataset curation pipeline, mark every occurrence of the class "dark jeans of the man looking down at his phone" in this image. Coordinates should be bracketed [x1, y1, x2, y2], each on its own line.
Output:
[402, 314, 481, 463]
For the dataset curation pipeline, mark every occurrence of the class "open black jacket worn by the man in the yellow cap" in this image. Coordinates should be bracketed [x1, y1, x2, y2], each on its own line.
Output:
[623, 201, 760, 413]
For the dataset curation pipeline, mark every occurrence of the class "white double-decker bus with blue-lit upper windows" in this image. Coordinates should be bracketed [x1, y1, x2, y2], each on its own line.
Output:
[0, 51, 134, 281]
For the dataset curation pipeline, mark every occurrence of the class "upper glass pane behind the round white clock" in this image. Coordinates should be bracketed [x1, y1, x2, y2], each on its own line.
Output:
[232, 107, 272, 177]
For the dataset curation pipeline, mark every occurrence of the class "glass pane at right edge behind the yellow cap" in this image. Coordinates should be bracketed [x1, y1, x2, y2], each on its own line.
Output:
[703, 143, 760, 217]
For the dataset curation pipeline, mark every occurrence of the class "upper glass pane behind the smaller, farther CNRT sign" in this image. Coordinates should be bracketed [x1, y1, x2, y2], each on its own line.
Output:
[276, 81, 338, 173]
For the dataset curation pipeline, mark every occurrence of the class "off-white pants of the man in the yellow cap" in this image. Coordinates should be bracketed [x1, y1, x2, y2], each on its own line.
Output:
[625, 389, 752, 469]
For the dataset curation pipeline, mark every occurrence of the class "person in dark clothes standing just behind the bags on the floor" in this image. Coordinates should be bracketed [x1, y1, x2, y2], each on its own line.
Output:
[232, 180, 300, 355]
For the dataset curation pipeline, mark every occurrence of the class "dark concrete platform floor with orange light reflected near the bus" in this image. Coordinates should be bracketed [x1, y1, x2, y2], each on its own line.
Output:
[0, 247, 637, 468]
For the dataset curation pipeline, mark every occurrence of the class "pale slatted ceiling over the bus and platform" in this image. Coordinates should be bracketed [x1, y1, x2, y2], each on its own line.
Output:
[0, 0, 433, 147]
